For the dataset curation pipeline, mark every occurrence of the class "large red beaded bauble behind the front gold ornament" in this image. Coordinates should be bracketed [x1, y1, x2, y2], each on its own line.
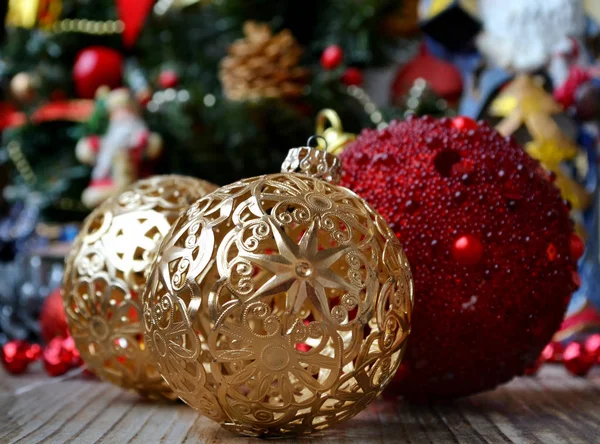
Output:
[340, 117, 576, 399]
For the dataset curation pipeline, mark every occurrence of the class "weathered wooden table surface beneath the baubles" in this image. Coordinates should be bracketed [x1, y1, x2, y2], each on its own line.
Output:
[0, 366, 600, 444]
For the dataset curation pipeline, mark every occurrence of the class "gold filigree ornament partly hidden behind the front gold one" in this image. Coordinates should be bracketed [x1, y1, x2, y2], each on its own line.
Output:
[63, 175, 217, 399]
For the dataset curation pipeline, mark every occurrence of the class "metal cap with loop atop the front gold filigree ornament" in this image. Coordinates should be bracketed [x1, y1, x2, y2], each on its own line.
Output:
[281, 136, 342, 184]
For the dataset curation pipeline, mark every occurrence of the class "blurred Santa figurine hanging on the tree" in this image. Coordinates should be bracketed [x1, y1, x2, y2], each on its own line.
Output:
[75, 88, 163, 208]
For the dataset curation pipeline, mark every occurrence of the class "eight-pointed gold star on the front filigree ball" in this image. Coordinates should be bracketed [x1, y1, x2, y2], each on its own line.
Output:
[242, 218, 359, 317]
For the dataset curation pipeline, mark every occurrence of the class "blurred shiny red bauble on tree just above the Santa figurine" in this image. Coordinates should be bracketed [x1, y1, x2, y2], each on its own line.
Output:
[73, 46, 123, 99]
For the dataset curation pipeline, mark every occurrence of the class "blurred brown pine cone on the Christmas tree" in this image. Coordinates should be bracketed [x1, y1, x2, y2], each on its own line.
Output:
[219, 21, 308, 100]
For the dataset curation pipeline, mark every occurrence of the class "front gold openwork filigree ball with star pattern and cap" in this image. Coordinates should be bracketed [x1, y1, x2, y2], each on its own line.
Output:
[143, 140, 413, 437]
